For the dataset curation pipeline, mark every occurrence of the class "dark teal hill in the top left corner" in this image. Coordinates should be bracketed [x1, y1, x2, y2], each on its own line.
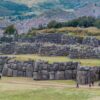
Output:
[0, 0, 30, 16]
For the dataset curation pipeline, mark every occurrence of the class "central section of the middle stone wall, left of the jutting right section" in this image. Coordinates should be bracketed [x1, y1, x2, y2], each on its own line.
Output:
[39, 45, 70, 56]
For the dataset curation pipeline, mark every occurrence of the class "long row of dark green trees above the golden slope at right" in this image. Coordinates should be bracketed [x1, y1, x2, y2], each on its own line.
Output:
[47, 16, 100, 28]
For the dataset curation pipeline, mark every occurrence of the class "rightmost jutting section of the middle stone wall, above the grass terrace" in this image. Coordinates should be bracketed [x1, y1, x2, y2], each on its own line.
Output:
[68, 46, 100, 59]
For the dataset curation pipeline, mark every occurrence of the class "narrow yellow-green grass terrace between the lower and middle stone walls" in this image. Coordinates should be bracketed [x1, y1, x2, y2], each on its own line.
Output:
[2, 54, 100, 66]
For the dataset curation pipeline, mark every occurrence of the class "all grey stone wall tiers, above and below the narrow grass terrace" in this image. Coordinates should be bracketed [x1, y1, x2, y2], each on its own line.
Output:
[0, 33, 100, 84]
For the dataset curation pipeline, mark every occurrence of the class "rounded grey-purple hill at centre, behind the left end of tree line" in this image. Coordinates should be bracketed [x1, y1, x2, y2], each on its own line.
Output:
[39, 8, 76, 21]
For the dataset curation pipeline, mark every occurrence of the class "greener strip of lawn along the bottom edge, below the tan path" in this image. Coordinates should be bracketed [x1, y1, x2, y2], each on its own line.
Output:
[0, 88, 93, 100]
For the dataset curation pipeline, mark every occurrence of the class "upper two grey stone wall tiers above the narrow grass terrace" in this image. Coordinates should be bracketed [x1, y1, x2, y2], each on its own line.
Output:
[0, 33, 100, 59]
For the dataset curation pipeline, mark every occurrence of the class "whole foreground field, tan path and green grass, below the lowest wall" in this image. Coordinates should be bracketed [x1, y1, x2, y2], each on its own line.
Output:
[0, 78, 100, 100]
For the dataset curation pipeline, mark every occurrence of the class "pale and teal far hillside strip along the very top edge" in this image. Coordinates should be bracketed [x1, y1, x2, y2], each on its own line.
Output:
[8, 0, 99, 9]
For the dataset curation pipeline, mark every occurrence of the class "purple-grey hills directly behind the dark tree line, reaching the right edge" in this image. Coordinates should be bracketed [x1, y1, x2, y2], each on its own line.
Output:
[36, 3, 100, 21]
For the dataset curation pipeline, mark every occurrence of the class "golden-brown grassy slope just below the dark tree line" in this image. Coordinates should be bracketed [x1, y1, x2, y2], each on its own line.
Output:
[30, 27, 100, 39]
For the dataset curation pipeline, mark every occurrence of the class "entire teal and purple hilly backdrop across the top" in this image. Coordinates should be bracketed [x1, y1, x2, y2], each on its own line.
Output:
[0, 0, 100, 21]
